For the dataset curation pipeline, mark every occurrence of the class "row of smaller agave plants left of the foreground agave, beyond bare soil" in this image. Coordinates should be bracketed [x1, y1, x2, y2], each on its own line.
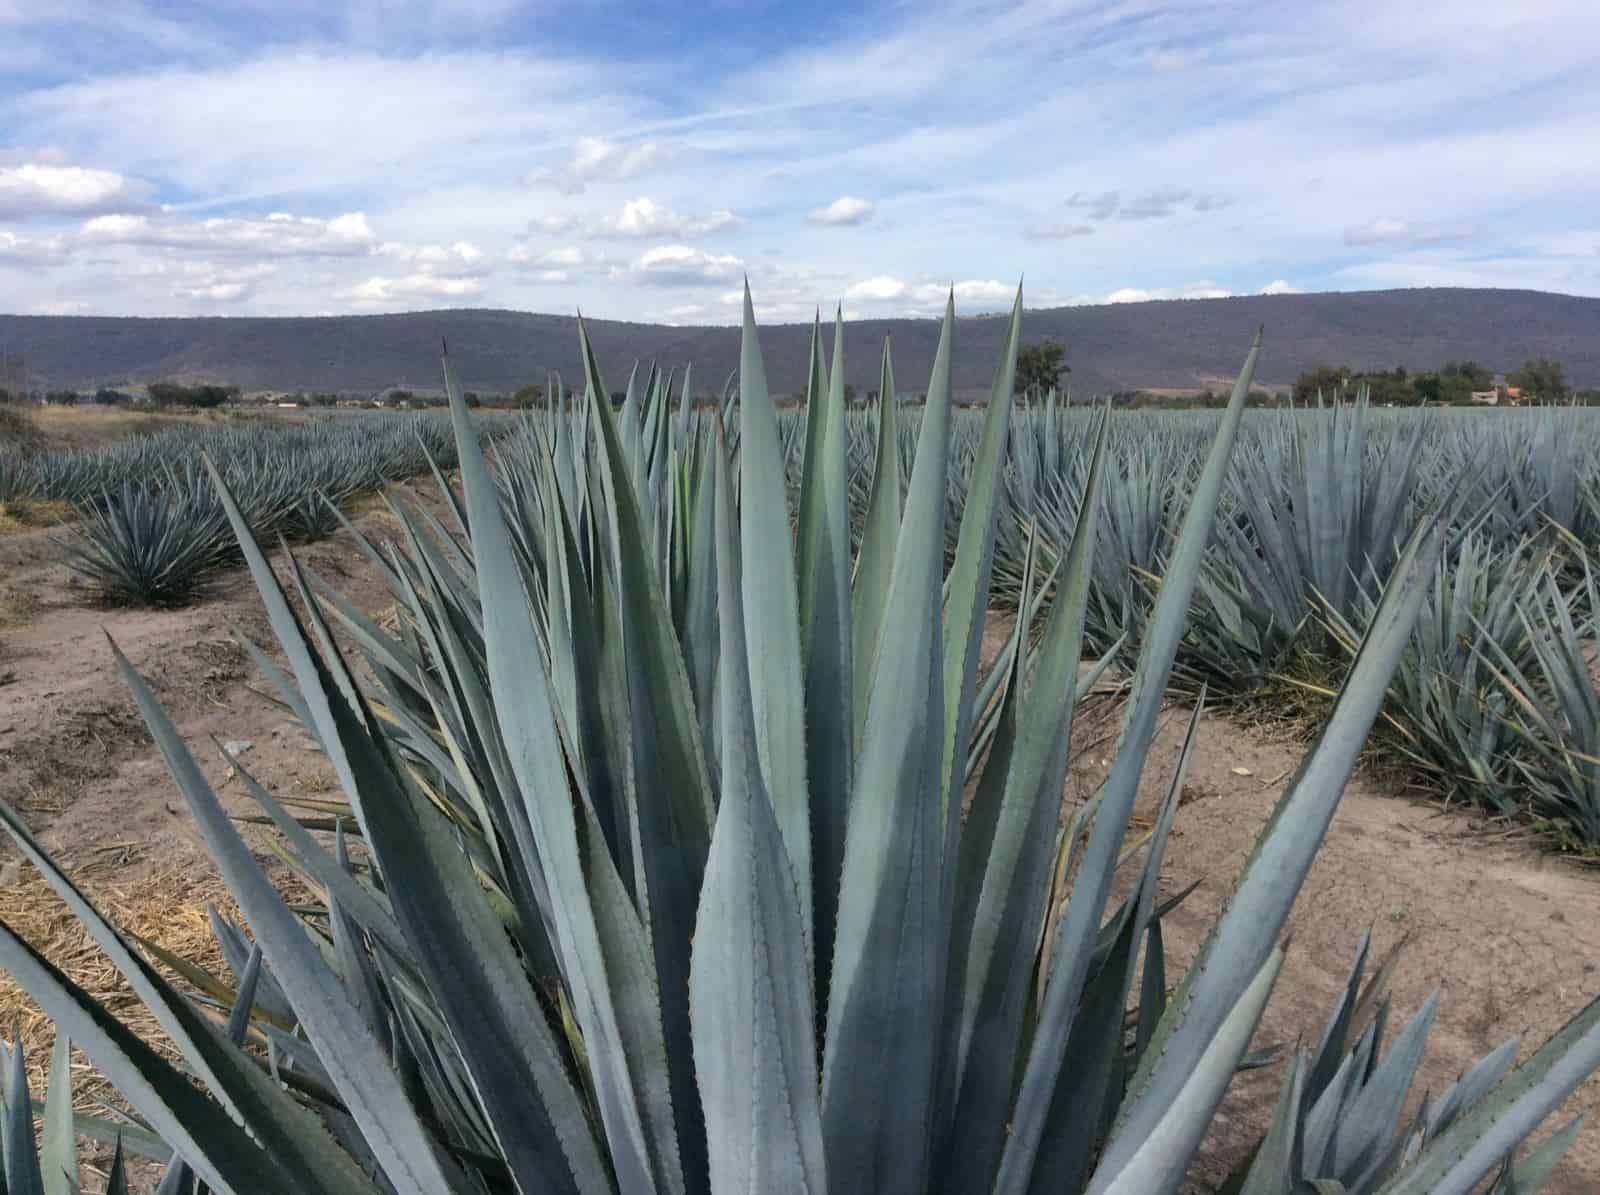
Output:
[48, 416, 486, 606]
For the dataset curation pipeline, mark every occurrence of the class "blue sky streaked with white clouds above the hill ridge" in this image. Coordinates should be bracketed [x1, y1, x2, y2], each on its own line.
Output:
[0, 0, 1600, 325]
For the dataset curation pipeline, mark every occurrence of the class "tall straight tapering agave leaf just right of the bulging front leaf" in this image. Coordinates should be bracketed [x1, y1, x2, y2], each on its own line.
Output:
[819, 299, 955, 1192]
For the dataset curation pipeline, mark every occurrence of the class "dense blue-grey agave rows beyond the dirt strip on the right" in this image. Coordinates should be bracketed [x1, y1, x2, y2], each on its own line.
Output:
[774, 398, 1600, 851]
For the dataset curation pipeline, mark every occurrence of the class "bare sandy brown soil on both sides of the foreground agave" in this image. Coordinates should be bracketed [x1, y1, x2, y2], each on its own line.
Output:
[0, 489, 1600, 1195]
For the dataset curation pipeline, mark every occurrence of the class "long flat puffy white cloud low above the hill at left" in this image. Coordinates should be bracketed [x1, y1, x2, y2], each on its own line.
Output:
[78, 211, 378, 258]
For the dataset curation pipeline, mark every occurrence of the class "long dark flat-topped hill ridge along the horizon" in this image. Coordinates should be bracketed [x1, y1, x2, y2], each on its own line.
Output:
[0, 290, 1600, 397]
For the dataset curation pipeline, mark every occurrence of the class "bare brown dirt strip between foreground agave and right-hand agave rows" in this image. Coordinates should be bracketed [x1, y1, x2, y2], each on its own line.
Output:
[1126, 710, 1600, 1195]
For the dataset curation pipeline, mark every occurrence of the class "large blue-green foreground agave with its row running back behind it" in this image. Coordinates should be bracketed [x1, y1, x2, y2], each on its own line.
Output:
[0, 284, 1600, 1195]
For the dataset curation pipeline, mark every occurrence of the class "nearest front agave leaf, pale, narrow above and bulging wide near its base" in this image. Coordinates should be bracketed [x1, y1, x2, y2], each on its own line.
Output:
[690, 435, 827, 1195]
